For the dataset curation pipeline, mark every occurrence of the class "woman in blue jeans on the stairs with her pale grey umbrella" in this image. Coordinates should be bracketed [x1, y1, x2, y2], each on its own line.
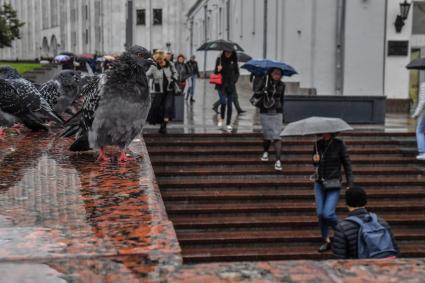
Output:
[281, 117, 353, 253]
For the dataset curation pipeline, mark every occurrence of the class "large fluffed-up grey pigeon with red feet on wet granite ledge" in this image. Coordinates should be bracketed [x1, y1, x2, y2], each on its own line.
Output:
[63, 52, 151, 162]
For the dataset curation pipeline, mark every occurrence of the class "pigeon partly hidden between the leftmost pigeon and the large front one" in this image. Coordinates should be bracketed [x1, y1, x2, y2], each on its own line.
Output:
[39, 70, 81, 113]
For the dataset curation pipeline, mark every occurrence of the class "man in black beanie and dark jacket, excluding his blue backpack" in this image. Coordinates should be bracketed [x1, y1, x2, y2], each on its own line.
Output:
[332, 187, 399, 259]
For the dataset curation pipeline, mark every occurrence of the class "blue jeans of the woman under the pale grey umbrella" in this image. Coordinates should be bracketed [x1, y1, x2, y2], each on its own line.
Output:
[314, 182, 340, 240]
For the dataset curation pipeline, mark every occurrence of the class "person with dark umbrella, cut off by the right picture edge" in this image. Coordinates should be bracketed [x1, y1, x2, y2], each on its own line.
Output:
[407, 58, 425, 160]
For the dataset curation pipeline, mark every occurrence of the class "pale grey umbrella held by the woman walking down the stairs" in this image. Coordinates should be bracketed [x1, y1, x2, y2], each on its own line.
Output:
[280, 117, 353, 137]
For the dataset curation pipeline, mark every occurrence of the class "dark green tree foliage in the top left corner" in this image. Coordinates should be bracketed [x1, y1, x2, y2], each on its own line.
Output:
[0, 3, 24, 48]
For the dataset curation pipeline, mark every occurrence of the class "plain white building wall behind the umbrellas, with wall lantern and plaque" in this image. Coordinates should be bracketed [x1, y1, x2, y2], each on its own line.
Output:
[188, 0, 423, 102]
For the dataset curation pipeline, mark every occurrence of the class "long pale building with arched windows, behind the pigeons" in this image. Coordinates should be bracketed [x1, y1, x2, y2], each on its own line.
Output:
[0, 0, 195, 60]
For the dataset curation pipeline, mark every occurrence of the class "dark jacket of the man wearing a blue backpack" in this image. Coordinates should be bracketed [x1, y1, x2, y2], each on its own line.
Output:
[332, 208, 399, 259]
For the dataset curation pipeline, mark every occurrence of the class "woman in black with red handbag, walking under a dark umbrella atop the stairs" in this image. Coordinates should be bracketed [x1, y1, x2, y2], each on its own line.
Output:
[214, 51, 239, 133]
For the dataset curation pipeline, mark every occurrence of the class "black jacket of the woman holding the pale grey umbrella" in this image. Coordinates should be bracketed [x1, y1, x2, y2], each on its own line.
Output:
[313, 138, 353, 186]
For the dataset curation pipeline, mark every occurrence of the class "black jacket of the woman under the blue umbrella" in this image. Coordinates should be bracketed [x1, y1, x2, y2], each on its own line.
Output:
[253, 76, 286, 114]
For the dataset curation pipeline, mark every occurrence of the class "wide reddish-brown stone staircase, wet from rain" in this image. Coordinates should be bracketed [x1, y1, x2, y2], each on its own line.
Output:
[145, 132, 425, 263]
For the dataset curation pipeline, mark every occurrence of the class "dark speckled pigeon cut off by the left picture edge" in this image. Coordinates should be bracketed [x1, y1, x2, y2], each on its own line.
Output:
[0, 67, 63, 131]
